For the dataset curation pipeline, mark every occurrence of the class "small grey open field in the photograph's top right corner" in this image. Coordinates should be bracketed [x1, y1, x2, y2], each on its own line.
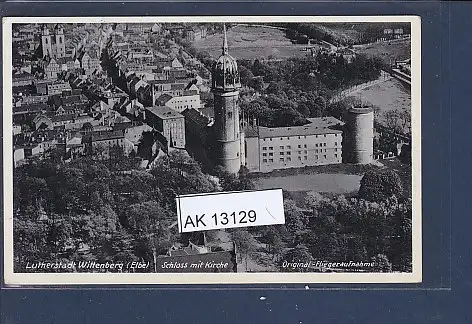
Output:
[354, 38, 411, 64]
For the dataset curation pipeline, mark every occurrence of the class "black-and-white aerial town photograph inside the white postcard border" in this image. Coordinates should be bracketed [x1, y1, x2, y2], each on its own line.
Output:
[10, 21, 416, 273]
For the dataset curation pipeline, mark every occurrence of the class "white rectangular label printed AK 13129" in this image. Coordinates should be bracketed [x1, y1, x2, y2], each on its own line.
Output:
[176, 189, 285, 233]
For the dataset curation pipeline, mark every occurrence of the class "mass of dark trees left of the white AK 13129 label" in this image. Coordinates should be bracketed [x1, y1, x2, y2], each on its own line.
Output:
[14, 152, 258, 272]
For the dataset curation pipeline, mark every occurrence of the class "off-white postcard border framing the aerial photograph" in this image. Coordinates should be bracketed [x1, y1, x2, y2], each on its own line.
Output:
[2, 16, 422, 286]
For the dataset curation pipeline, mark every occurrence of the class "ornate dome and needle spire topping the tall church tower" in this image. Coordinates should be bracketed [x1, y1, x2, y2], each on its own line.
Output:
[212, 25, 241, 91]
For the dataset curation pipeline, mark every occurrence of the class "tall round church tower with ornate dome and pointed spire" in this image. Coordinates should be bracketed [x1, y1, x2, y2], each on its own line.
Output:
[212, 26, 243, 173]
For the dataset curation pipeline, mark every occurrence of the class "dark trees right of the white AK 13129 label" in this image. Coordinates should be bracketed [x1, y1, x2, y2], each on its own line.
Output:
[225, 169, 412, 272]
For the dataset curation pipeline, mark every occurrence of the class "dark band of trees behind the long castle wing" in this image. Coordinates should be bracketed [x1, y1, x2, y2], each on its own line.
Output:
[234, 54, 381, 127]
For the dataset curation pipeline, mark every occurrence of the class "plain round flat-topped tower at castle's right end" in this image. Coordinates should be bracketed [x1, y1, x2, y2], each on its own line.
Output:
[343, 106, 374, 164]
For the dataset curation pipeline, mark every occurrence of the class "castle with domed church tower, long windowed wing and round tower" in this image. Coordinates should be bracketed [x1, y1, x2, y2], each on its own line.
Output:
[183, 29, 374, 173]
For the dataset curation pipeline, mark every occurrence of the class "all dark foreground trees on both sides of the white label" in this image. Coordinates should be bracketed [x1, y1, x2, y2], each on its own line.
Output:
[14, 143, 411, 272]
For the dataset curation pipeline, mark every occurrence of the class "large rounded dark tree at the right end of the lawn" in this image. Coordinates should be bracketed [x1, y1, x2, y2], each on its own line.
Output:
[358, 168, 403, 201]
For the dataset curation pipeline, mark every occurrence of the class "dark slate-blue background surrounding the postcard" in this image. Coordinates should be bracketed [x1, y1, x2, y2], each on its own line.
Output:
[0, 1, 472, 324]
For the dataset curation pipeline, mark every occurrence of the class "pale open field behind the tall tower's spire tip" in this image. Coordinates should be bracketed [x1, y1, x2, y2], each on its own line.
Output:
[193, 26, 306, 59]
